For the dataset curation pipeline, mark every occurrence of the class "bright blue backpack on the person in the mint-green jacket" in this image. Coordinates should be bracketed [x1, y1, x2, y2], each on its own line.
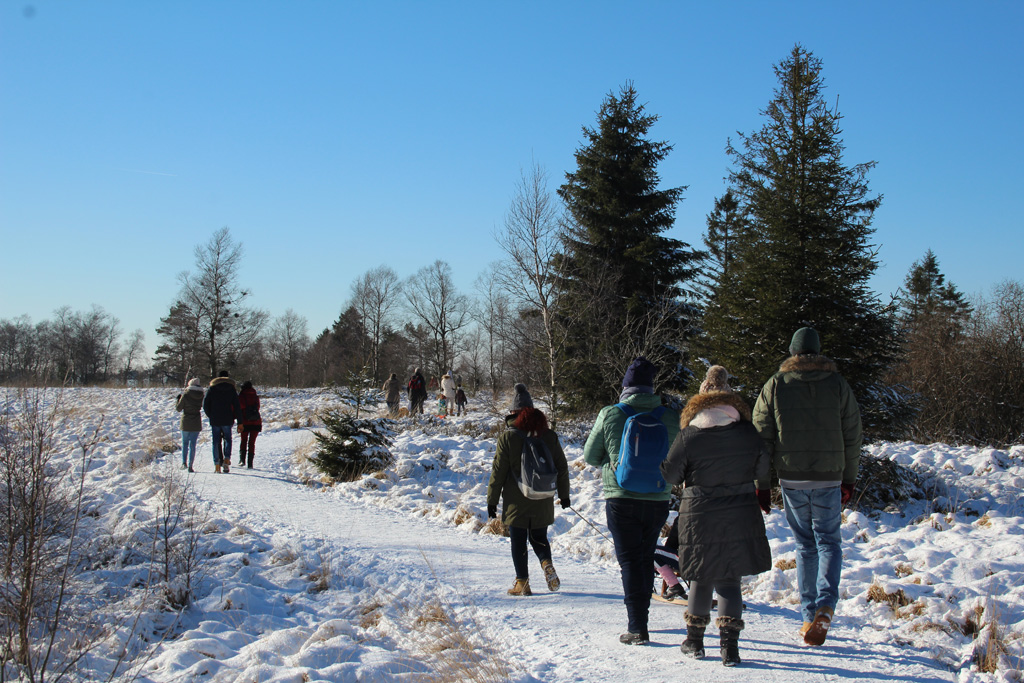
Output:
[615, 403, 669, 494]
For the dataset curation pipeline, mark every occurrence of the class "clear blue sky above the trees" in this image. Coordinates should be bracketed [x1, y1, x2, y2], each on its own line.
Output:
[0, 0, 1024, 353]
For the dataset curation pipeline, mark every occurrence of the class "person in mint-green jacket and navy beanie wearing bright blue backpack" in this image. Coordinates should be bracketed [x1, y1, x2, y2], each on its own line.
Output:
[583, 356, 679, 645]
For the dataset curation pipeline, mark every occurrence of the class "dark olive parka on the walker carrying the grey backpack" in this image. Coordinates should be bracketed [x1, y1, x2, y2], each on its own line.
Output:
[487, 415, 569, 528]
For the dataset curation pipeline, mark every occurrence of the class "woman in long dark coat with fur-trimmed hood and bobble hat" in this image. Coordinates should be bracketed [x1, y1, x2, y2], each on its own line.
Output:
[662, 366, 771, 667]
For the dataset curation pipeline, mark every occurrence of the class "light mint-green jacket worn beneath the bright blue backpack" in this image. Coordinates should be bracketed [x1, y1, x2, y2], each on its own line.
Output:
[583, 393, 679, 501]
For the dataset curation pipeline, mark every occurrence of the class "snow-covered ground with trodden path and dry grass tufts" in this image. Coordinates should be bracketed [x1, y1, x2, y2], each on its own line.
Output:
[5, 389, 1024, 683]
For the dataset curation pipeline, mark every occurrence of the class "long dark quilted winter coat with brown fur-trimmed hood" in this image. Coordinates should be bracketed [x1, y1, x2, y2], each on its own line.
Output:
[662, 392, 771, 583]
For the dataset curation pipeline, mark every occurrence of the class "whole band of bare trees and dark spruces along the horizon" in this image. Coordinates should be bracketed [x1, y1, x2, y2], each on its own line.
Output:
[0, 45, 1024, 443]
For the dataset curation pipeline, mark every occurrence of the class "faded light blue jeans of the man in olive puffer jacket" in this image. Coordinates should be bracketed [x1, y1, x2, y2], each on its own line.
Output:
[782, 486, 843, 622]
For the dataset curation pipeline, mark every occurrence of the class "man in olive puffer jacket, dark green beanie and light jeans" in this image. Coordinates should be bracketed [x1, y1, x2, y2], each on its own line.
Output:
[754, 328, 862, 645]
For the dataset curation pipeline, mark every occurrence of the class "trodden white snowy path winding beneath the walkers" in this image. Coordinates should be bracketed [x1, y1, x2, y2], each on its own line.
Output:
[186, 430, 952, 683]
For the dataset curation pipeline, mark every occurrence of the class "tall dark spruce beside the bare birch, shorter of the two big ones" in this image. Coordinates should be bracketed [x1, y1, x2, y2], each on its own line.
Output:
[555, 83, 699, 401]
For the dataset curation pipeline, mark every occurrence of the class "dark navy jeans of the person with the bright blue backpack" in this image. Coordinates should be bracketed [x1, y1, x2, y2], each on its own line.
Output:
[604, 498, 669, 635]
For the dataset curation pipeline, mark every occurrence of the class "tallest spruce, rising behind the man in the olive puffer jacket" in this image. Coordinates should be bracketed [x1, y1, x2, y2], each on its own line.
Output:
[703, 45, 909, 436]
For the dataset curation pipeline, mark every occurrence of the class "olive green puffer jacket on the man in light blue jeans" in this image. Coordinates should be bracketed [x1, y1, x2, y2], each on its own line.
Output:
[754, 355, 863, 488]
